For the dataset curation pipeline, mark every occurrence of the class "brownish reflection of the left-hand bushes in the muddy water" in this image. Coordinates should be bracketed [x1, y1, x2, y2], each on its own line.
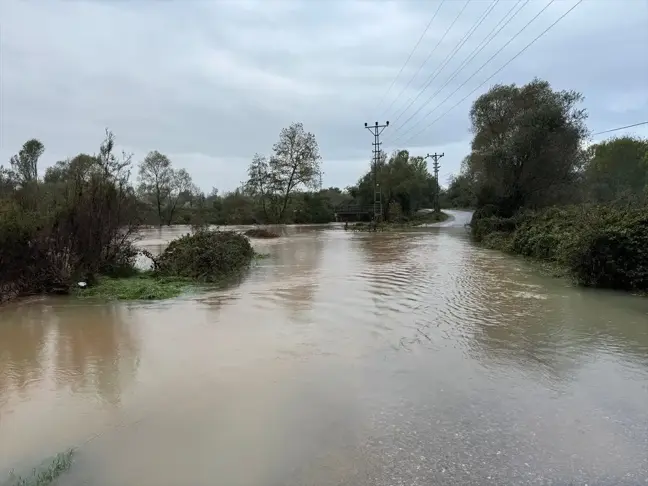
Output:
[0, 299, 138, 410]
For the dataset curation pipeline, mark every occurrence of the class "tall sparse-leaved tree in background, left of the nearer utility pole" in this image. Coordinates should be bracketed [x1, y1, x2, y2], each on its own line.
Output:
[246, 123, 321, 222]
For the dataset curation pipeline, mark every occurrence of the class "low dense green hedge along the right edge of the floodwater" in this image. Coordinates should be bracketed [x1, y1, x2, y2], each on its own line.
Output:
[471, 205, 648, 292]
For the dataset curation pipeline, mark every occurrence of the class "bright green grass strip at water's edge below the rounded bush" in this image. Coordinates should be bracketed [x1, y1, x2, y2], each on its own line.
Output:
[74, 272, 192, 300]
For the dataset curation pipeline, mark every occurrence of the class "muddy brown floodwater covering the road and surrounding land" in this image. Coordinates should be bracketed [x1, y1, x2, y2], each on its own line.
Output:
[0, 212, 648, 486]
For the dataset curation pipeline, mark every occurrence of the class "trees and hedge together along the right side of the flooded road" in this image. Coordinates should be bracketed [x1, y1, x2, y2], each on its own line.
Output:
[456, 80, 648, 290]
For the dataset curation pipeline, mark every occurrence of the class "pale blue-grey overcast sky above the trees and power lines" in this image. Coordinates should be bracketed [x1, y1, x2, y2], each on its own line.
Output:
[0, 0, 648, 191]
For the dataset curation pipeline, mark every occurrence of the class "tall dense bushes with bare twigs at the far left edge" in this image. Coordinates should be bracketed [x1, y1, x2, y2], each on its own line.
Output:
[0, 132, 137, 300]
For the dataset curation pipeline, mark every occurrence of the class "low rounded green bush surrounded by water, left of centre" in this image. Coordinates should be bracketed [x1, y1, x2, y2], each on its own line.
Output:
[155, 231, 254, 282]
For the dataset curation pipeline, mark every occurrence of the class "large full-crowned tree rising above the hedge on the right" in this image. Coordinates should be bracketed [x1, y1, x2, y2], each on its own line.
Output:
[469, 79, 587, 216]
